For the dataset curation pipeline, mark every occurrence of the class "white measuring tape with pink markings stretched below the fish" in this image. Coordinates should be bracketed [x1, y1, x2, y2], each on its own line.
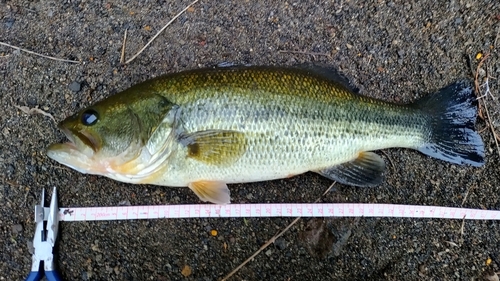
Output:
[45, 203, 500, 221]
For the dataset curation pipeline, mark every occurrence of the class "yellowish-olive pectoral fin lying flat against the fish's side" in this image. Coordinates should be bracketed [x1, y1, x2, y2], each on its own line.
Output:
[181, 130, 246, 165]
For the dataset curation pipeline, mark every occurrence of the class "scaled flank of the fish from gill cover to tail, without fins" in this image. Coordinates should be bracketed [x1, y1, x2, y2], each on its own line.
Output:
[146, 68, 426, 186]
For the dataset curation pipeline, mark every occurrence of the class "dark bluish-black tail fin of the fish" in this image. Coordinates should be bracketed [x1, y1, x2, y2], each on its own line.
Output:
[414, 82, 484, 167]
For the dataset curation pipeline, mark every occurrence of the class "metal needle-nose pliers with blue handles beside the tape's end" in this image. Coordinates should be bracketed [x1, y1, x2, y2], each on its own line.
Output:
[26, 187, 62, 281]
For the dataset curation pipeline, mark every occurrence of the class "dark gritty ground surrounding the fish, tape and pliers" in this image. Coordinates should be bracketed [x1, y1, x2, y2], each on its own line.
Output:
[0, 0, 500, 280]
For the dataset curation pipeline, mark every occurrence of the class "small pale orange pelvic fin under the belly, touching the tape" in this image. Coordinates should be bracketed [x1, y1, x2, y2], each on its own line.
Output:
[188, 181, 231, 204]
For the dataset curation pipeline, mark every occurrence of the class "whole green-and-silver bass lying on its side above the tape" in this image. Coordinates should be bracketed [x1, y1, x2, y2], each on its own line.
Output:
[47, 65, 485, 204]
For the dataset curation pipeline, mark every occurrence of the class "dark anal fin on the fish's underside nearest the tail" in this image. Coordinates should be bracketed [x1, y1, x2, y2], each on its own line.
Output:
[316, 152, 385, 187]
